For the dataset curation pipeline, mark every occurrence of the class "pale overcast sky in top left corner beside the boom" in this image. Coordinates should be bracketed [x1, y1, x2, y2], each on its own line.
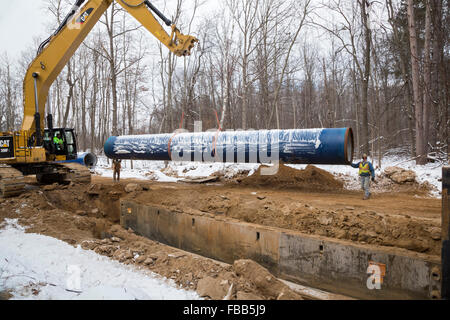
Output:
[0, 0, 48, 57]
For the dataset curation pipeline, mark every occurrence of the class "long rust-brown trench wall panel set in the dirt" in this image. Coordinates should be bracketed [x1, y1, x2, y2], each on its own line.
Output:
[121, 200, 440, 299]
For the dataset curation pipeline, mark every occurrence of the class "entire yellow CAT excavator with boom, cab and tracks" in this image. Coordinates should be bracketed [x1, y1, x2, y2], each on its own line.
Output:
[0, 0, 198, 197]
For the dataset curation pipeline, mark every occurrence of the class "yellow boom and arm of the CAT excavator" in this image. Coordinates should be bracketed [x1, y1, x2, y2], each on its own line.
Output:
[22, 0, 198, 140]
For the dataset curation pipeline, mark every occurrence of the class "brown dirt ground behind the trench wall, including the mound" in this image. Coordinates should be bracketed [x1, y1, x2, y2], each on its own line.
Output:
[134, 166, 441, 256]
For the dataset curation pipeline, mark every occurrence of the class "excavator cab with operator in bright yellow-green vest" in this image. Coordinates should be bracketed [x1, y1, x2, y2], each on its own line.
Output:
[44, 128, 77, 160]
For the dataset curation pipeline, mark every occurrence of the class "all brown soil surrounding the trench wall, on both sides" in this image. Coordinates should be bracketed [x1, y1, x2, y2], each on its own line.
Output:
[0, 166, 441, 299]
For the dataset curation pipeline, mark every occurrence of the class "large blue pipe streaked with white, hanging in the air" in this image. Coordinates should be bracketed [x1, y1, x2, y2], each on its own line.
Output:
[104, 128, 353, 165]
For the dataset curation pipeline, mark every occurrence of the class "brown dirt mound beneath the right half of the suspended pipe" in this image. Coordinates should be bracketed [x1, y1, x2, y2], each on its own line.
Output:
[241, 164, 344, 191]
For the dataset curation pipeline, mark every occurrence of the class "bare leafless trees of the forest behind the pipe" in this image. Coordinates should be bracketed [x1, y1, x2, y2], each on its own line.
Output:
[0, 0, 450, 163]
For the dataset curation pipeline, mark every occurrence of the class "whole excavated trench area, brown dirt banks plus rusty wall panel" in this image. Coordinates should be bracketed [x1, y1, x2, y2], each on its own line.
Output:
[0, 169, 440, 299]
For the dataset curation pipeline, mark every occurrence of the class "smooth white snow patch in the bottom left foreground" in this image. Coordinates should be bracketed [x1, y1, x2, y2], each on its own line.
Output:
[0, 219, 199, 300]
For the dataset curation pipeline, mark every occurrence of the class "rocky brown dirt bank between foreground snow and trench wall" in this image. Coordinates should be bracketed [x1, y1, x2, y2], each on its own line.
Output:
[0, 177, 303, 300]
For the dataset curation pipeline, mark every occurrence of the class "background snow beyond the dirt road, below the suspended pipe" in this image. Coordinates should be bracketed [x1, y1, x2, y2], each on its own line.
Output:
[95, 156, 442, 197]
